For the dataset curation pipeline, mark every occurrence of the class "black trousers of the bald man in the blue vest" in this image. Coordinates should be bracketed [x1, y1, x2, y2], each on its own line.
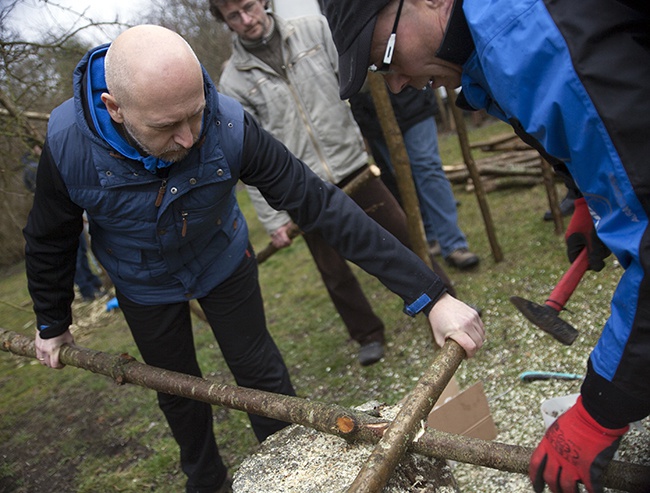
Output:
[117, 248, 295, 493]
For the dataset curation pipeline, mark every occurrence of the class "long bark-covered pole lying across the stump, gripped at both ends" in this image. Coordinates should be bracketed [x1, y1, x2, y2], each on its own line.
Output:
[0, 328, 650, 493]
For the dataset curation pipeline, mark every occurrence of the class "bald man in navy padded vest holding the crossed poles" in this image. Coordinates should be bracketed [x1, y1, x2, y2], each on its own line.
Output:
[24, 26, 484, 493]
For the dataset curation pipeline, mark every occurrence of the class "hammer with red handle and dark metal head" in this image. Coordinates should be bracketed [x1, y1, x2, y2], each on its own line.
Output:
[510, 248, 589, 346]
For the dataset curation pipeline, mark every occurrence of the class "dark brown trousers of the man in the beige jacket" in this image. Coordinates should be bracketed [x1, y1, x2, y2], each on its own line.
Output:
[304, 169, 455, 345]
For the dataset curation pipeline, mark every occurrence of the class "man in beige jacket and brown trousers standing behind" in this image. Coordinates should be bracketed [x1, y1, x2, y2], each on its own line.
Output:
[210, 0, 454, 366]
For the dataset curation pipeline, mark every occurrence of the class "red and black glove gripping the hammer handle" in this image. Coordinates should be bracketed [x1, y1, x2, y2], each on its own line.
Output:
[564, 197, 612, 272]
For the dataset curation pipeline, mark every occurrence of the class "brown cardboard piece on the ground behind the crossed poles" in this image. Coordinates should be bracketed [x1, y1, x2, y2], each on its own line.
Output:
[427, 378, 497, 440]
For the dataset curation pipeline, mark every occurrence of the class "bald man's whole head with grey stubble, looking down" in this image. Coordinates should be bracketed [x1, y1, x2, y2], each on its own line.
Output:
[101, 25, 206, 162]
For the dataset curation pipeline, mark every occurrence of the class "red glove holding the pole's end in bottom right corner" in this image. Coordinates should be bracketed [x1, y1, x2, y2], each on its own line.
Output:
[528, 396, 630, 493]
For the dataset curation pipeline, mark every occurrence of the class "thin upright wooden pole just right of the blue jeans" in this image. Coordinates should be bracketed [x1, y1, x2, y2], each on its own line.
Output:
[445, 88, 503, 262]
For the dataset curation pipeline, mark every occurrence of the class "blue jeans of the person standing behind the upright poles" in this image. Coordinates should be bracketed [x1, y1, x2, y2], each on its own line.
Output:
[369, 117, 467, 257]
